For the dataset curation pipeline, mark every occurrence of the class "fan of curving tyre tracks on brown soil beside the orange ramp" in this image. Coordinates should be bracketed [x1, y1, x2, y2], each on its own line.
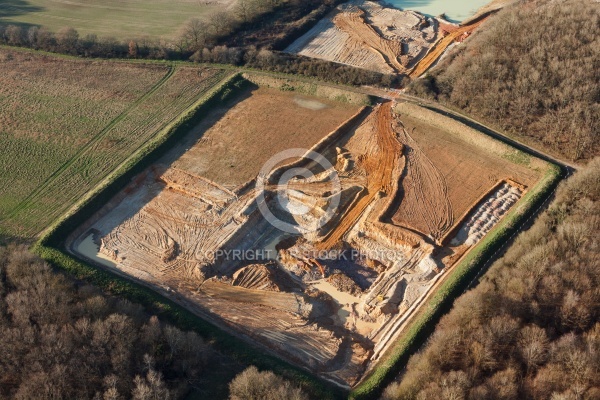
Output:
[392, 127, 454, 241]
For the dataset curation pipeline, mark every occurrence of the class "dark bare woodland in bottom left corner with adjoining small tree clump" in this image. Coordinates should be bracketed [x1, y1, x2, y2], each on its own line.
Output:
[0, 245, 306, 400]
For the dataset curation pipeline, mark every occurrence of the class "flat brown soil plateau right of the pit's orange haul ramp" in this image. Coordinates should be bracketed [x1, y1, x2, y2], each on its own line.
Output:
[392, 115, 540, 241]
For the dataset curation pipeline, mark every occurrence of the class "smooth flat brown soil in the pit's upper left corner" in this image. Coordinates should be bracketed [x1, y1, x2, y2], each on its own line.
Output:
[165, 88, 358, 188]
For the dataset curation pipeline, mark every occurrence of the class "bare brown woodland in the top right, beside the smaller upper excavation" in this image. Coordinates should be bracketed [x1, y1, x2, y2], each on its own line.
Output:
[411, 0, 600, 160]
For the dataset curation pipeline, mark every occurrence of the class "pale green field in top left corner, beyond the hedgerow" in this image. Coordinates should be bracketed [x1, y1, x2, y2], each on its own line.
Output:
[0, 0, 233, 40]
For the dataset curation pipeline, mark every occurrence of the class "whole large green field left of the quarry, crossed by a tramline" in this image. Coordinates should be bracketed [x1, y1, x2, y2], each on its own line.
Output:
[0, 49, 230, 238]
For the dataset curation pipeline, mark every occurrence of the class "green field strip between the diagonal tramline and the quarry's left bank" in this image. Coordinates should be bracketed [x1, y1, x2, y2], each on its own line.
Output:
[7, 70, 233, 237]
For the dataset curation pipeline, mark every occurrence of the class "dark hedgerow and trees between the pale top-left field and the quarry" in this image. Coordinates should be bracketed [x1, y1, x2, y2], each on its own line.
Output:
[0, 0, 401, 87]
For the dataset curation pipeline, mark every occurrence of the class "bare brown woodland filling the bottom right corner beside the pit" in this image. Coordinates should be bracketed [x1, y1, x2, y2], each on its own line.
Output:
[384, 158, 600, 400]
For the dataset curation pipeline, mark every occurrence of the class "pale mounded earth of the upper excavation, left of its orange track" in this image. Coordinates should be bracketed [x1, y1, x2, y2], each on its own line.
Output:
[286, 0, 438, 73]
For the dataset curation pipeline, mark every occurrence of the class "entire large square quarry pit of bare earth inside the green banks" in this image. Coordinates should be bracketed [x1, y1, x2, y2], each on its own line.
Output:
[68, 76, 548, 386]
